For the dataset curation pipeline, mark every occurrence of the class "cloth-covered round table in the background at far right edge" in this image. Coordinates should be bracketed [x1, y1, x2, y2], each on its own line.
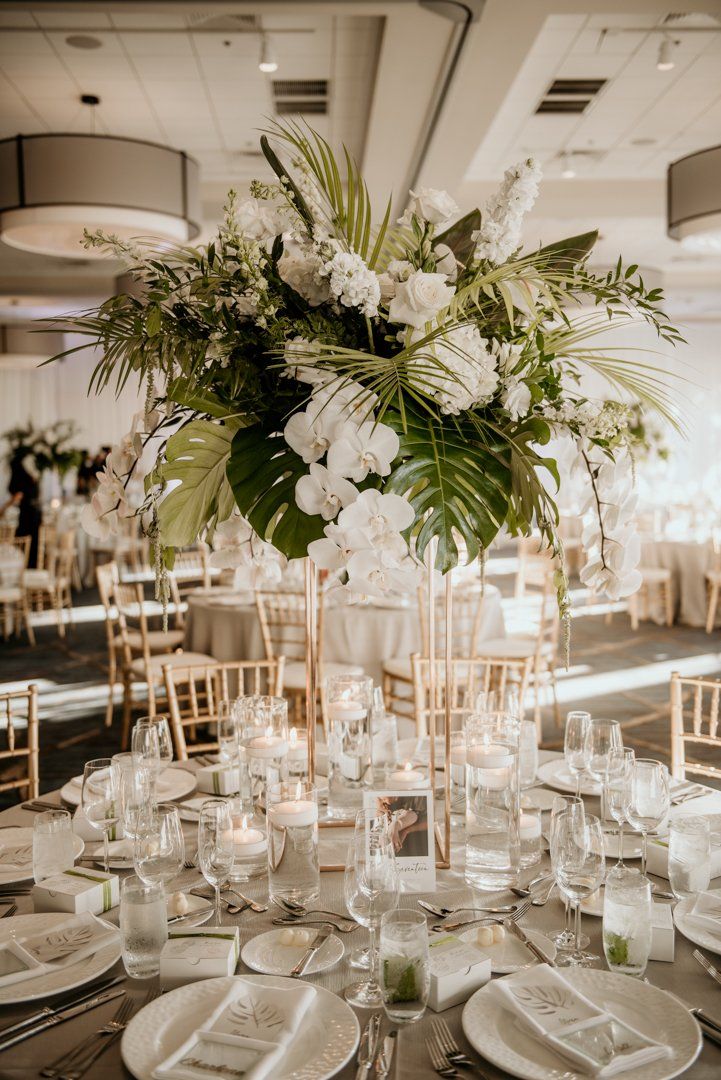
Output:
[641, 538, 713, 626]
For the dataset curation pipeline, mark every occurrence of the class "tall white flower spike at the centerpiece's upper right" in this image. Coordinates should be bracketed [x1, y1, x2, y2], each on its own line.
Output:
[472, 158, 542, 265]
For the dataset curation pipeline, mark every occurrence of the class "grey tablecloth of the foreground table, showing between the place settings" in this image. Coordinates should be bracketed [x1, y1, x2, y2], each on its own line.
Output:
[0, 751, 721, 1080]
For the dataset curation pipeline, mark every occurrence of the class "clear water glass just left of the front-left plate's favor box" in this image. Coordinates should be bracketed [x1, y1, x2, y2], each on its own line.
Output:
[120, 876, 167, 978]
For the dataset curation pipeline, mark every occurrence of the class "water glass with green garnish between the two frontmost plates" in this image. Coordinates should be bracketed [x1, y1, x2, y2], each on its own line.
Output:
[380, 907, 431, 1024]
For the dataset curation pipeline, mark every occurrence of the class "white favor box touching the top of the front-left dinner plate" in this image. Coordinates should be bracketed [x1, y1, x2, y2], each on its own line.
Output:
[160, 927, 241, 989]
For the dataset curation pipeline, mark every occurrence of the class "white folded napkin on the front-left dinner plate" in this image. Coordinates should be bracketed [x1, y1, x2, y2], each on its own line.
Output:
[153, 978, 315, 1080]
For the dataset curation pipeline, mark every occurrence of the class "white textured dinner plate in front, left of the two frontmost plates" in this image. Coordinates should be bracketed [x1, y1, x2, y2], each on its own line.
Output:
[121, 972, 362, 1080]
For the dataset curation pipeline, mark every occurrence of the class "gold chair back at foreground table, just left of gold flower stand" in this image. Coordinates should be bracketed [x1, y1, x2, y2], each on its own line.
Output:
[163, 657, 285, 761]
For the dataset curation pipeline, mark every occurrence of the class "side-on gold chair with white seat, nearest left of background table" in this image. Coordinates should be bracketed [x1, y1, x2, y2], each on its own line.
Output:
[112, 581, 217, 746]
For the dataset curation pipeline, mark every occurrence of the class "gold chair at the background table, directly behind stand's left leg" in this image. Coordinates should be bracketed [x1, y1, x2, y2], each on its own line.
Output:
[256, 590, 363, 724]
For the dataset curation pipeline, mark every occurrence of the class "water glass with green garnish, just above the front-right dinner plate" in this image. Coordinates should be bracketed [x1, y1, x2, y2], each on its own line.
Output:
[603, 866, 653, 978]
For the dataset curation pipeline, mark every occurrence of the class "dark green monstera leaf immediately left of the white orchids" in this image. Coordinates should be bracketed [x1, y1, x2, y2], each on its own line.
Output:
[228, 427, 325, 558]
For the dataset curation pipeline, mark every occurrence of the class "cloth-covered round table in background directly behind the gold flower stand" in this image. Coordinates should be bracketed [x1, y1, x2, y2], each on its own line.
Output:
[185, 585, 505, 684]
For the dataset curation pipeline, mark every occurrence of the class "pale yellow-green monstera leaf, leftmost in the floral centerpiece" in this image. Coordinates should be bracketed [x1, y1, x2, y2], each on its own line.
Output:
[158, 420, 234, 548]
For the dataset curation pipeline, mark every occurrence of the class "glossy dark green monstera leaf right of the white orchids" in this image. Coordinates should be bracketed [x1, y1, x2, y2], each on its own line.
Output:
[383, 414, 512, 572]
